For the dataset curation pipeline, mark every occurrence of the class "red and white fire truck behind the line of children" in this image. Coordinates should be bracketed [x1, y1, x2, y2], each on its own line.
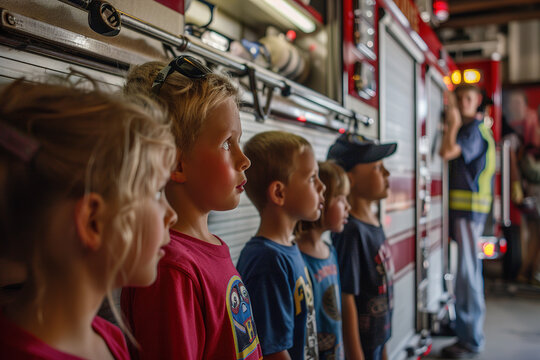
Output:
[0, 0, 497, 359]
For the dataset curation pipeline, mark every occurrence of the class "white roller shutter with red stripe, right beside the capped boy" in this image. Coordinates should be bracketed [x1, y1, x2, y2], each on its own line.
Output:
[379, 28, 416, 358]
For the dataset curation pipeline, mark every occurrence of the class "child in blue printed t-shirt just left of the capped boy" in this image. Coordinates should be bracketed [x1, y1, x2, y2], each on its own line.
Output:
[295, 161, 350, 360]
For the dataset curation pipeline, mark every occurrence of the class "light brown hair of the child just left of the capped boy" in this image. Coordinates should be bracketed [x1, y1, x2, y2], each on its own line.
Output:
[294, 160, 350, 236]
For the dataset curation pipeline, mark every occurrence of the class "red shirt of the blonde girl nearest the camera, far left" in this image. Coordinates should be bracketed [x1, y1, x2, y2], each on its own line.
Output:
[0, 311, 129, 360]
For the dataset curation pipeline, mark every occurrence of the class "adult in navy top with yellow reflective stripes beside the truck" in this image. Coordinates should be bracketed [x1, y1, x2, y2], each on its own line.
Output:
[439, 84, 495, 358]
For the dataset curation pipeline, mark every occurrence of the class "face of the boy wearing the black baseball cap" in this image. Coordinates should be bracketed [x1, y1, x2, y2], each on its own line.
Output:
[348, 160, 390, 200]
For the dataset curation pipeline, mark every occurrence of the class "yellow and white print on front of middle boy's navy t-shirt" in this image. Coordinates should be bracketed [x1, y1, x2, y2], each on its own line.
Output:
[294, 267, 318, 360]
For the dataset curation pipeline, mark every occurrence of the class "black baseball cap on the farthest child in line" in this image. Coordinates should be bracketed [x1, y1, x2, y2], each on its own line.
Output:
[327, 133, 397, 171]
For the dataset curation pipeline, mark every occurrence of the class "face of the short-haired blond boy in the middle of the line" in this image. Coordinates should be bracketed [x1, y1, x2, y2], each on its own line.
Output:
[285, 149, 325, 221]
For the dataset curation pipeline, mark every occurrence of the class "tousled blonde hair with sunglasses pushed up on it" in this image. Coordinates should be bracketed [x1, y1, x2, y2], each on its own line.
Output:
[124, 61, 240, 154]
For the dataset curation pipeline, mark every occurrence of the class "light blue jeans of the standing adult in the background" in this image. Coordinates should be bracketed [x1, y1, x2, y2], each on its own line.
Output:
[452, 218, 486, 352]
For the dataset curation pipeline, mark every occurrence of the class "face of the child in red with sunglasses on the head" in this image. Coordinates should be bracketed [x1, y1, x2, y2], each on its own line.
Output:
[185, 99, 251, 211]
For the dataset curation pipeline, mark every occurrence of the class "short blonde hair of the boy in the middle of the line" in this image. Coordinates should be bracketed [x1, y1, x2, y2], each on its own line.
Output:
[244, 131, 311, 212]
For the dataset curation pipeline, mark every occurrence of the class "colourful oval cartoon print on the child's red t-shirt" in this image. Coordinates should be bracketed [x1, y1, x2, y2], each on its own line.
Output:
[227, 275, 259, 360]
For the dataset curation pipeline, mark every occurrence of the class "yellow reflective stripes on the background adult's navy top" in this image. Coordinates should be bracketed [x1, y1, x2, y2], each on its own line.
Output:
[449, 123, 496, 214]
